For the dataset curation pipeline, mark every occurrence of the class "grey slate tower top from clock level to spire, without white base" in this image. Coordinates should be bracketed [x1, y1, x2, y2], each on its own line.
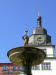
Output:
[29, 16, 51, 45]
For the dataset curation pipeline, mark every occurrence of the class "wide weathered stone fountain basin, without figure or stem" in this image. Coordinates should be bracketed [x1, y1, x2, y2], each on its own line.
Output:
[7, 46, 46, 66]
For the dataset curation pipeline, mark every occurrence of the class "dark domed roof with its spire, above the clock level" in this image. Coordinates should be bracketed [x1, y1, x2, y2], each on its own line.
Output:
[33, 16, 47, 34]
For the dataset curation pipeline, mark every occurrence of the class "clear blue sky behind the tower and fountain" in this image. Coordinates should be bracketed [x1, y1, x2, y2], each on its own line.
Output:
[0, 0, 56, 63]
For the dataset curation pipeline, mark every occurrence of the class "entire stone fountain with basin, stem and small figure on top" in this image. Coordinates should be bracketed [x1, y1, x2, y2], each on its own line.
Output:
[7, 31, 46, 75]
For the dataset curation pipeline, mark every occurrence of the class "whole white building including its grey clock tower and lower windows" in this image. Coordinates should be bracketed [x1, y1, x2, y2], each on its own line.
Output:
[28, 16, 56, 75]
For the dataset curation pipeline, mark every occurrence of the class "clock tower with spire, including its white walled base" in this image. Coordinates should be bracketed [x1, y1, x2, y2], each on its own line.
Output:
[28, 16, 55, 57]
